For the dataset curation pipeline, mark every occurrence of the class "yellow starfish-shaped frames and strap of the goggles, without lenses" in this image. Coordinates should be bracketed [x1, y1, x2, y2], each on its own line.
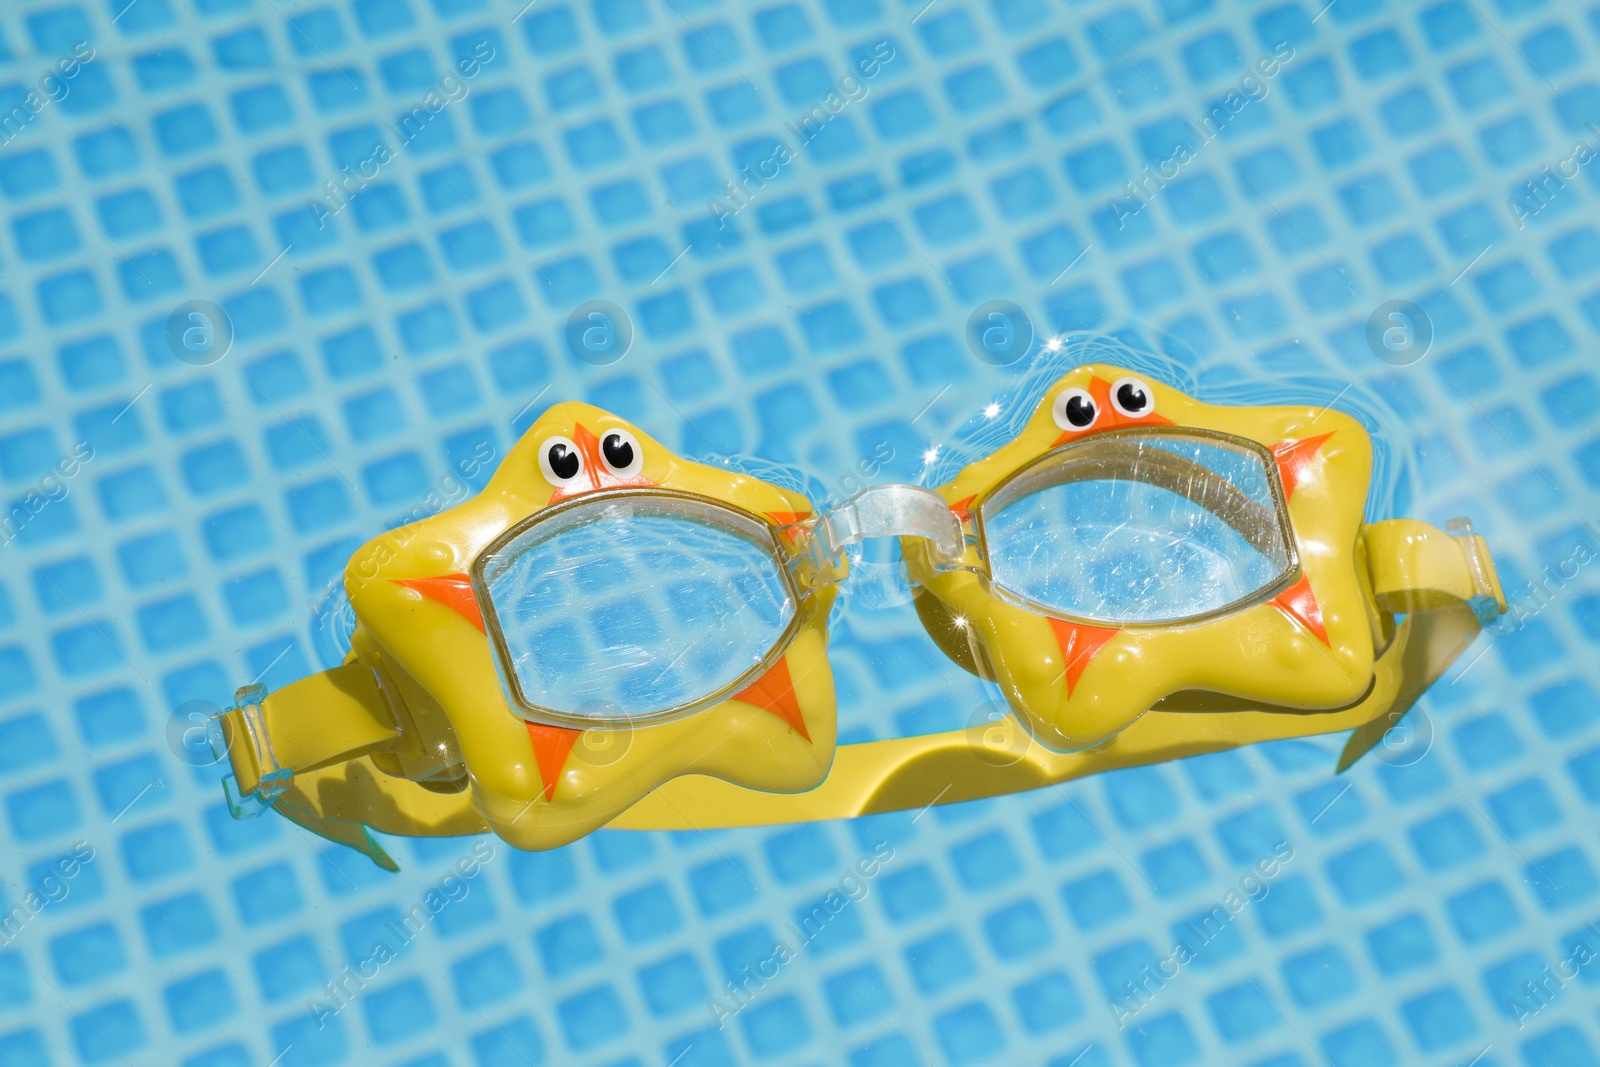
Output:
[221, 382, 1504, 867]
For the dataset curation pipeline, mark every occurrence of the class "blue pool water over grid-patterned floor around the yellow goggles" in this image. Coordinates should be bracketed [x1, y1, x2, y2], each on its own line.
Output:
[0, 0, 1600, 1067]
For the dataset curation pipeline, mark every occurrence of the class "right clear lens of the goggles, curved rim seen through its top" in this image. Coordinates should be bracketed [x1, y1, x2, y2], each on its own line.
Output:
[982, 432, 1296, 624]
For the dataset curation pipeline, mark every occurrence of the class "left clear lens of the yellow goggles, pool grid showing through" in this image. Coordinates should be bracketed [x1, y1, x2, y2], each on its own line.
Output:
[482, 498, 797, 721]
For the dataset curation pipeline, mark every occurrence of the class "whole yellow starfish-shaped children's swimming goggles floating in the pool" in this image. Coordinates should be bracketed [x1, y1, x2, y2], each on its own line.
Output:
[214, 365, 1506, 865]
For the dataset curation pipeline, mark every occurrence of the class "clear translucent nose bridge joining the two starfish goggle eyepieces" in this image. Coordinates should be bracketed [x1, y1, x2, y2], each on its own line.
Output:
[792, 483, 966, 579]
